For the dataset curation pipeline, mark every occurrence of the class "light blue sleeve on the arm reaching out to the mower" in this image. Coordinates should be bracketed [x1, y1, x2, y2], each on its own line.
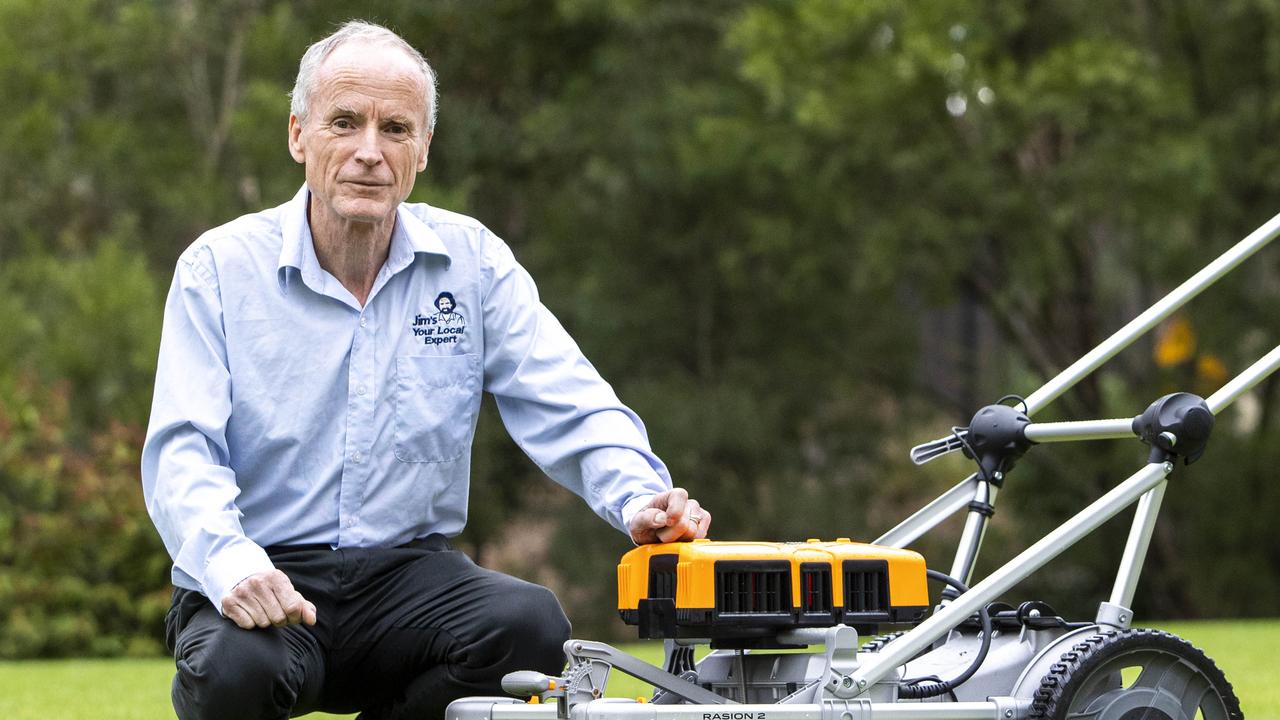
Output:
[481, 233, 671, 533]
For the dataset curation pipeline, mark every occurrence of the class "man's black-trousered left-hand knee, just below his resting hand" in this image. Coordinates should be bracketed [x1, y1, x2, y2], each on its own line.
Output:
[173, 623, 297, 720]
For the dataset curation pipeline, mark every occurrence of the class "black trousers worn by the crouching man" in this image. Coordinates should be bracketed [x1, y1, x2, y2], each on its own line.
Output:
[165, 536, 570, 720]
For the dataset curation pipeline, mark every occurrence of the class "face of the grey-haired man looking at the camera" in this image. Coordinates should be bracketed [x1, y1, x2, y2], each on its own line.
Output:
[289, 42, 431, 223]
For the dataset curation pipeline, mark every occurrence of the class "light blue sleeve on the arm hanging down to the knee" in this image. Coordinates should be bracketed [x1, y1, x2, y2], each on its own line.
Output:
[142, 246, 273, 604]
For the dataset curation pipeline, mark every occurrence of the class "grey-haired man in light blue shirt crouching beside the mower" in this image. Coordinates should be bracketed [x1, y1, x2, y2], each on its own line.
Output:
[142, 22, 710, 719]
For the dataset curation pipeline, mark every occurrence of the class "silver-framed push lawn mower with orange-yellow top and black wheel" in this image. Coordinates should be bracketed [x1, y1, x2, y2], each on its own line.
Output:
[447, 215, 1280, 720]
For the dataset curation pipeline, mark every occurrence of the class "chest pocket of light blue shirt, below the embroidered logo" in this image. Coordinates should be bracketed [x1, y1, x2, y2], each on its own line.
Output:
[394, 354, 480, 462]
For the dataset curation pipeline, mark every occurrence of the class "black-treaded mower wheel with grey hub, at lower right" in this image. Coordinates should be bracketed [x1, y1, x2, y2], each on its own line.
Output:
[1032, 629, 1244, 720]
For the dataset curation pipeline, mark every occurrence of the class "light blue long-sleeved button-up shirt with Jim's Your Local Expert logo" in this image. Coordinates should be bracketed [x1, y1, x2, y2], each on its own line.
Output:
[142, 187, 671, 610]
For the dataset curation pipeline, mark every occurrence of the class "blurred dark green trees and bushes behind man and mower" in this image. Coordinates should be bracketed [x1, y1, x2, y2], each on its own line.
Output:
[0, 0, 1280, 657]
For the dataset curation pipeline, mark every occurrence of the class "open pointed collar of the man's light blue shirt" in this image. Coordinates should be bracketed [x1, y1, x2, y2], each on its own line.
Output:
[276, 184, 452, 292]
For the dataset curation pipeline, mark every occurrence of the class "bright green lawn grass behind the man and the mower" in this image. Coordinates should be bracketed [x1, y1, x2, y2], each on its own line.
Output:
[0, 620, 1280, 720]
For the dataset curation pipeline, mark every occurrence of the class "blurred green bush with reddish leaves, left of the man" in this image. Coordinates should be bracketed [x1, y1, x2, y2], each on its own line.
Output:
[0, 374, 169, 657]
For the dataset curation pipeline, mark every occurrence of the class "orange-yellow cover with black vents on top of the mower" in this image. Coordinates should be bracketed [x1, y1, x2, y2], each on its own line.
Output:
[618, 538, 929, 646]
